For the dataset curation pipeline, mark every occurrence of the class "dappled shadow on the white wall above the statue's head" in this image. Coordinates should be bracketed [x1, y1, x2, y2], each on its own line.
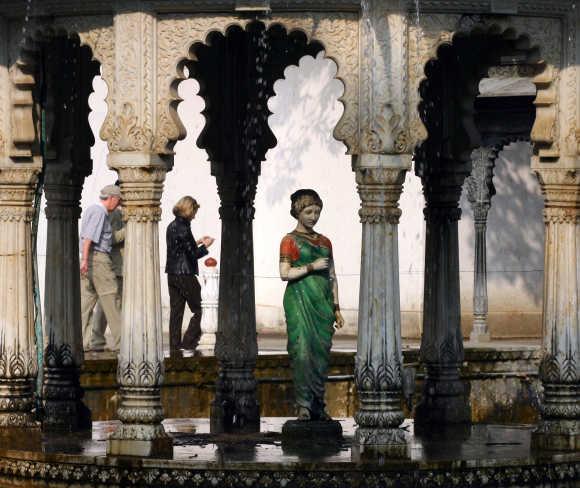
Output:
[266, 51, 345, 205]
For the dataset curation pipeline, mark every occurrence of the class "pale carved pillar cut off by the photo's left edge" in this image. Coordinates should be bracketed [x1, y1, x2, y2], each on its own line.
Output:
[0, 168, 39, 427]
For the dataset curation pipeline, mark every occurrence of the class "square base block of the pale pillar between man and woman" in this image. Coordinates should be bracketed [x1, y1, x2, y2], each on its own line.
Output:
[107, 424, 173, 458]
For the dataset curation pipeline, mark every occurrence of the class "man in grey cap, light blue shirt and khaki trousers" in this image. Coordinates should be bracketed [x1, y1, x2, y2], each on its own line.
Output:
[80, 185, 121, 351]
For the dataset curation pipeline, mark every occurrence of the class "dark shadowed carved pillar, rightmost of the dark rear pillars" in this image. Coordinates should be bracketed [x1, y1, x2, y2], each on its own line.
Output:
[415, 173, 471, 427]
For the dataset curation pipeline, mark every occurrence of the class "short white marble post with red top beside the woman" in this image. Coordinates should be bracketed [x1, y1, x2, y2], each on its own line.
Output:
[197, 258, 220, 355]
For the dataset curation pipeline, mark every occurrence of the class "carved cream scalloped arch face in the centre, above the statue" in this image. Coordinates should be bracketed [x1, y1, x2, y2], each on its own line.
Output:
[155, 13, 359, 155]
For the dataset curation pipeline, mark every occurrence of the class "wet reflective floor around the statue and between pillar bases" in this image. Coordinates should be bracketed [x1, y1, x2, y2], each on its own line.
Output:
[9, 417, 556, 465]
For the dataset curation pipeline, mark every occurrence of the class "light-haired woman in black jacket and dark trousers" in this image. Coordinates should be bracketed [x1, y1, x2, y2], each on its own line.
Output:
[165, 196, 214, 357]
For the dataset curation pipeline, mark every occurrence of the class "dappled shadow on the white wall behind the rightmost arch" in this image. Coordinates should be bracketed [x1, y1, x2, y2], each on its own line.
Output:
[461, 142, 544, 304]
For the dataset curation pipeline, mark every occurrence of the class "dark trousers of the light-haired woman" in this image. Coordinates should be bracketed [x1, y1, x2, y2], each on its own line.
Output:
[167, 274, 201, 352]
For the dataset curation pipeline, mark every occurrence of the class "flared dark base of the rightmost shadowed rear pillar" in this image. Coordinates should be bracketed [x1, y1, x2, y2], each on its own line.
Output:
[415, 371, 471, 426]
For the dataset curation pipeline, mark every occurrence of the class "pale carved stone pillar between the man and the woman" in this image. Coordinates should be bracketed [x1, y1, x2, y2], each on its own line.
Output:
[107, 157, 173, 456]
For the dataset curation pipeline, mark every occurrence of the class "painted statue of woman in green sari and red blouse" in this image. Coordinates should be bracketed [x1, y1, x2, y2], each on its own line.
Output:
[280, 189, 344, 420]
